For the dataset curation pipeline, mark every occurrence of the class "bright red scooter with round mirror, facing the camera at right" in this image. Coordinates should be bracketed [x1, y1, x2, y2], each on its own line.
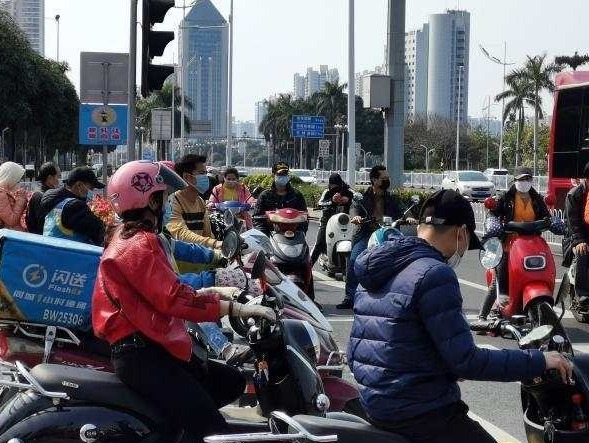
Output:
[471, 198, 562, 333]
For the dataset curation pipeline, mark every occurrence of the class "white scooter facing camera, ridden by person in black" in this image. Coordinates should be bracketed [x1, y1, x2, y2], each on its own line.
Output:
[319, 202, 358, 280]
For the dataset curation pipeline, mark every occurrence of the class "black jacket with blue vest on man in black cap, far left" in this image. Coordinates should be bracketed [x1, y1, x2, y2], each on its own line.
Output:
[39, 186, 104, 246]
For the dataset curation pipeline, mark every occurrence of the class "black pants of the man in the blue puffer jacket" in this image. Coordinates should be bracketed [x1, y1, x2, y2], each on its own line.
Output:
[373, 401, 497, 443]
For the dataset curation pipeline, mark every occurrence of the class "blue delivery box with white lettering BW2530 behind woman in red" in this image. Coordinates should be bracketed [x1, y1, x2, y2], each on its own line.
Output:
[0, 229, 102, 331]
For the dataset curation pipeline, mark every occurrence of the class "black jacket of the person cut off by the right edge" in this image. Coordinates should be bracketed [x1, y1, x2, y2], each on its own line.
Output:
[562, 183, 589, 266]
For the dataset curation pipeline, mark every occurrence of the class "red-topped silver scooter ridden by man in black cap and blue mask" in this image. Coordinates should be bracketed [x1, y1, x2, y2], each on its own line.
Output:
[254, 208, 315, 300]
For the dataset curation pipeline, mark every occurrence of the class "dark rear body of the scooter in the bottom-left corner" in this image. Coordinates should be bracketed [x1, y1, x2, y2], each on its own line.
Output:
[0, 391, 164, 443]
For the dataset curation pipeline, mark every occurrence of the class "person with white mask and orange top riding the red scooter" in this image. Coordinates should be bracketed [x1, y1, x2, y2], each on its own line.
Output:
[470, 166, 550, 323]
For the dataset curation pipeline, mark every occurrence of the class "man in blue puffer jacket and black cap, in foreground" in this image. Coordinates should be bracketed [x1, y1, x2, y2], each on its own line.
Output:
[348, 190, 572, 443]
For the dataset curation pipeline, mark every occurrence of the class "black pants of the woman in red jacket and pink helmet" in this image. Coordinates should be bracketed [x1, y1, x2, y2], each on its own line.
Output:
[113, 342, 245, 442]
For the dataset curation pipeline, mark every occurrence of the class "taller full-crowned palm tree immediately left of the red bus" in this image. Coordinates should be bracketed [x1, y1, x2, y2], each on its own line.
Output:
[507, 54, 560, 175]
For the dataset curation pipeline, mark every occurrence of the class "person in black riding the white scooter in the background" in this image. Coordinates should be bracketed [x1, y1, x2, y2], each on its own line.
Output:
[311, 172, 353, 265]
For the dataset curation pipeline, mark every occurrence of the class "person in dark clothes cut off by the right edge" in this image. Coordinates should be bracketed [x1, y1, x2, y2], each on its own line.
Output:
[563, 163, 589, 312]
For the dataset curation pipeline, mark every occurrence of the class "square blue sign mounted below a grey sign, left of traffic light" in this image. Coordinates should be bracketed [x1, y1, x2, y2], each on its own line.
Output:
[79, 104, 128, 146]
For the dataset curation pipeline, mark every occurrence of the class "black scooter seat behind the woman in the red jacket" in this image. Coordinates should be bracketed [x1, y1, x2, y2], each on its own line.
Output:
[31, 364, 162, 422]
